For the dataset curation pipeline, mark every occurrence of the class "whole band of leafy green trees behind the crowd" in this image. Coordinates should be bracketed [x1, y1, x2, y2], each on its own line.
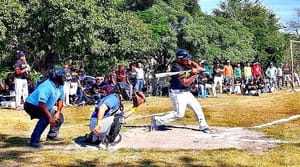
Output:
[0, 0, 289, 75]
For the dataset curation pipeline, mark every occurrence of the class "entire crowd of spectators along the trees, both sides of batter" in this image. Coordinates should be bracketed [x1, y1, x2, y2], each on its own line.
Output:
[0, 56, 300, 109]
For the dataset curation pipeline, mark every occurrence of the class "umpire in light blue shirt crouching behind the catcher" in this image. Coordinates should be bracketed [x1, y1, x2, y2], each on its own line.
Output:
[24, 67, 66, 148]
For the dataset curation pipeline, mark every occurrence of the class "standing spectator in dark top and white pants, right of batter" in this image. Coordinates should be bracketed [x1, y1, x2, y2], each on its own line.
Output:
[212, 62, 223, 98]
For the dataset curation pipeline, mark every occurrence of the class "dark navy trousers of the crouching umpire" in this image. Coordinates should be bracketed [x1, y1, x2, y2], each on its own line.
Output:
[24, 102, 64, 143]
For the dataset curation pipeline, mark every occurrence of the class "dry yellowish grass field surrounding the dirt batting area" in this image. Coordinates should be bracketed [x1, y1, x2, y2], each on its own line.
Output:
[0, 91, 300, 167]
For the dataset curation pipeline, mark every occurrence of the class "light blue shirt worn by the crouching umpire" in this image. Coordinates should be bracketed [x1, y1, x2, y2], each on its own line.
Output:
[26, 79, 65, 111]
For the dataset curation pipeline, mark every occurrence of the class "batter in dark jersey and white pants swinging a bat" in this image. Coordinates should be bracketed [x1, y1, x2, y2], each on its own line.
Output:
[150, 49, 212, 133]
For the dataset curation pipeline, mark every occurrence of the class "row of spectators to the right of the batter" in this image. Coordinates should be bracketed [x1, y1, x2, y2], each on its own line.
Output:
[191, 60, 300, 98]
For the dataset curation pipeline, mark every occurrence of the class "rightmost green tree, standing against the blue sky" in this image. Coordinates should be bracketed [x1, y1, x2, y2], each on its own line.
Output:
[213, 0, 287, 66]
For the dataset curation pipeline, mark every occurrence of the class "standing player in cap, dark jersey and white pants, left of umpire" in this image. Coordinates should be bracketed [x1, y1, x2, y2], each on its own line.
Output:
[14, 51, 31, 110]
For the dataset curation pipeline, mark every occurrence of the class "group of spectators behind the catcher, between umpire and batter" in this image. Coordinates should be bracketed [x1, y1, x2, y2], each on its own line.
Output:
[57, 63, 144, 106]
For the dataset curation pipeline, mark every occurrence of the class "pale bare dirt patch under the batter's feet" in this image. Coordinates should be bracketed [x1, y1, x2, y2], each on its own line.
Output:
[71, 126, 283, 152]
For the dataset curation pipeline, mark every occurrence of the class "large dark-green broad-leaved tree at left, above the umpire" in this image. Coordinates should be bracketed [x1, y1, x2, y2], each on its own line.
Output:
[0, 0, 152, 73]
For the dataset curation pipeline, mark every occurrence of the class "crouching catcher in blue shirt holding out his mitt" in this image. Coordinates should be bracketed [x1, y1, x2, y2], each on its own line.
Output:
[85, 84, 145, 147]
